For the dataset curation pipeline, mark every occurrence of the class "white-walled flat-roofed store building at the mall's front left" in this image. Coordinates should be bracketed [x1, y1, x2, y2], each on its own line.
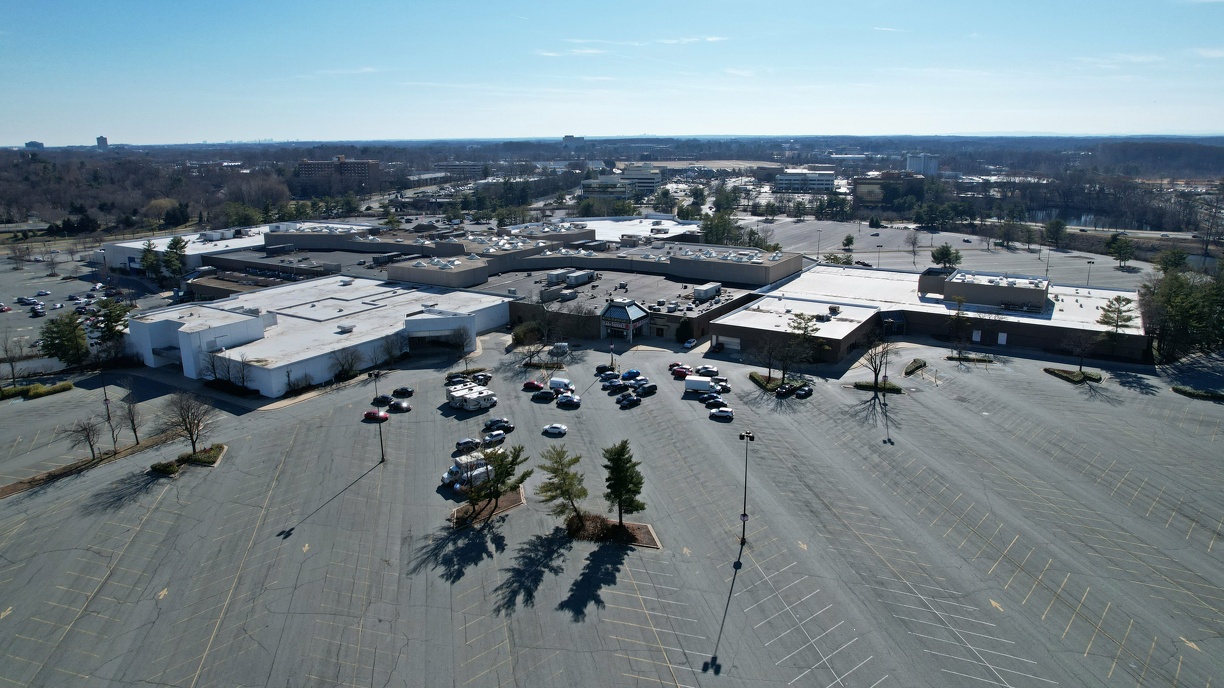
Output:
[129, 277, 513, 397]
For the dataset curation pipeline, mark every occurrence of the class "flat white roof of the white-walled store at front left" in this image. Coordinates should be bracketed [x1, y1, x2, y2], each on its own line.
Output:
[133, 275, 513, 367]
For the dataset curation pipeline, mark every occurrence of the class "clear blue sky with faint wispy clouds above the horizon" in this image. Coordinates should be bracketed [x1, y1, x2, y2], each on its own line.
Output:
[0, 0, 1224, 146]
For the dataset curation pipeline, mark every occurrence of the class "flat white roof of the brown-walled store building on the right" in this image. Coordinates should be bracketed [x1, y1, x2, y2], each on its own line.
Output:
[714, 264, 1142, 338]
